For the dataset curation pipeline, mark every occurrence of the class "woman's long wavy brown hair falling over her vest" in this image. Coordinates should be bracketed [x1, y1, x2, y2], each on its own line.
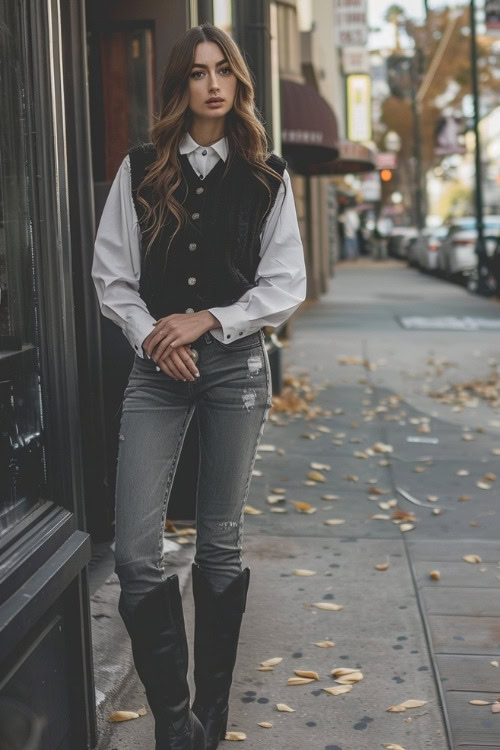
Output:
[137, 23, 283, 252]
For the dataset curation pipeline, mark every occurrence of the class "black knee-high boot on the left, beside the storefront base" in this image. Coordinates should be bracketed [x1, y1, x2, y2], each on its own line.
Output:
[118, 575, 206, 750]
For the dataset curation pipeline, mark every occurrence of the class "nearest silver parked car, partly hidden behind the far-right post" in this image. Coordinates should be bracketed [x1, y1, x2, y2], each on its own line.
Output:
[437, 216, 500, 281]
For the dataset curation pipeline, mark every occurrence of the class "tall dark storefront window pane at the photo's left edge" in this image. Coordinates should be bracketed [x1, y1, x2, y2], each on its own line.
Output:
[0, 0, 45, 535]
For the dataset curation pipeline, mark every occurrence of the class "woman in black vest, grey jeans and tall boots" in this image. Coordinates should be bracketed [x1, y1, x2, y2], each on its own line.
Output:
[92, 24, 305, 750]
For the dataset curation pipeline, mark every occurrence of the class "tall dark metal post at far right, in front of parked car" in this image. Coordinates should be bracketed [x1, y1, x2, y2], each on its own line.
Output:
[470, 0, 488, 294]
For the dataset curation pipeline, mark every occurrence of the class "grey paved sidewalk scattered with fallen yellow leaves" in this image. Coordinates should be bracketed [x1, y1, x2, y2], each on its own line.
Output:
[92, 260, 500, 750]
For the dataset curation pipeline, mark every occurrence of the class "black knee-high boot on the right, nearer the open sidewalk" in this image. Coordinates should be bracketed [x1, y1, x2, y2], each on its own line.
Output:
[189, 564, 250, 750]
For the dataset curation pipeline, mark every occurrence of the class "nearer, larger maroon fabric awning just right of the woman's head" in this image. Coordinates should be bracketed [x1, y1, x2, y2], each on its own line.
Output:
[280, 80, 339, 172]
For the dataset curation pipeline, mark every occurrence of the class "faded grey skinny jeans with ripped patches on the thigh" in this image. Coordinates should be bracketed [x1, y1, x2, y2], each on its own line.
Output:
[115, 331, 272, 609]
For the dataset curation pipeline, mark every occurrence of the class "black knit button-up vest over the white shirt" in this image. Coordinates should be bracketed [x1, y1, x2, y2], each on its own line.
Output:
[129, 144, 286, 319]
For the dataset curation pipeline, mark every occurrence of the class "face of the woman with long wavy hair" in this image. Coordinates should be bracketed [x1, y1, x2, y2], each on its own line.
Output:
[189, 42, 238, 120]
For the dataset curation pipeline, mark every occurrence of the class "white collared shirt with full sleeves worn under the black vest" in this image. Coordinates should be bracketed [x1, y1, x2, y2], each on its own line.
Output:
[92, 133, 306, 357]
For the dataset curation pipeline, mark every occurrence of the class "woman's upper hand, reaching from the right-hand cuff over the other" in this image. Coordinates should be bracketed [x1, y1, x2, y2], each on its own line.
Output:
[142, 310, 220, 363]
